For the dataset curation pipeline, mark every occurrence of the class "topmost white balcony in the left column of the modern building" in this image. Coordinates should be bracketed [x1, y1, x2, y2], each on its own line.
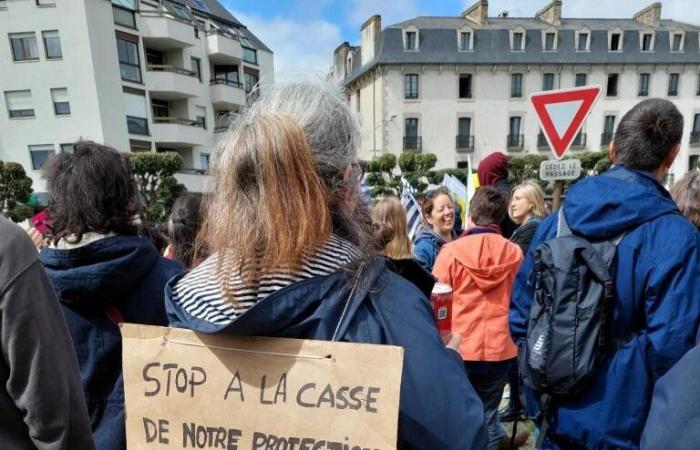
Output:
[139, 11, 197, 50]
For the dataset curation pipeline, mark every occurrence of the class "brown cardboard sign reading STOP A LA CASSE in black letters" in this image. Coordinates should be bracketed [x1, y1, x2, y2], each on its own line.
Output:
[121, 324, 403, 450]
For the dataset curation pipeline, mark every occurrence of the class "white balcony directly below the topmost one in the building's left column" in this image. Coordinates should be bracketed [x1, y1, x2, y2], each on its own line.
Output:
[145, 65, 201, 100]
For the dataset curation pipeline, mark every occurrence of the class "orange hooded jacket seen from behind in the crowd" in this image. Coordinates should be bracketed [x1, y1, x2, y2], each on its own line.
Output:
[433, 233, 523, 361]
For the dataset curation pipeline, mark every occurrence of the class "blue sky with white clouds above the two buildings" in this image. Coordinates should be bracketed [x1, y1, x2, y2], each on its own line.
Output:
[219, 0, 700, 73]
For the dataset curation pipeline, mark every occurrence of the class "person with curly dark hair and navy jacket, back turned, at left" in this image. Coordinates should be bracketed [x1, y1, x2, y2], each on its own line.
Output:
[41, 141, 182, 450]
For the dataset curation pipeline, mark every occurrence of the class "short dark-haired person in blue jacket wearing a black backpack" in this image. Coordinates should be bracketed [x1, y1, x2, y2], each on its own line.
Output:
[510, 99, 700, 449]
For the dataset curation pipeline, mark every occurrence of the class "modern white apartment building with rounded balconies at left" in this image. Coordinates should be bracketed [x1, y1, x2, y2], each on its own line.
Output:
[0, 0, 273, 192]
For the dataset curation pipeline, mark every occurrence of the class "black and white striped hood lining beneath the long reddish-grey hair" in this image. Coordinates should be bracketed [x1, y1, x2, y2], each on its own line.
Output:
[172, 235, 360, 325]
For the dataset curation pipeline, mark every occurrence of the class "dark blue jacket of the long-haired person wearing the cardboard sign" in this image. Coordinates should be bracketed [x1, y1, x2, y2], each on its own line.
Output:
[166, 258, 485, 450]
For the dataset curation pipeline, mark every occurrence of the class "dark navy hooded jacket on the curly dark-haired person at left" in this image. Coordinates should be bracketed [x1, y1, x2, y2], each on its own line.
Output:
[41, 236, 183, 450]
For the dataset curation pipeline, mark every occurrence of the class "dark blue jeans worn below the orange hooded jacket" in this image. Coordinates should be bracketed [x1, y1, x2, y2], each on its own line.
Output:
[464, 360, 515, 450]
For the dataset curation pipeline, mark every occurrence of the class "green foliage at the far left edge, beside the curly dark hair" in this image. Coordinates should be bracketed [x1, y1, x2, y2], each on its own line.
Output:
[0, 161, 34, 222]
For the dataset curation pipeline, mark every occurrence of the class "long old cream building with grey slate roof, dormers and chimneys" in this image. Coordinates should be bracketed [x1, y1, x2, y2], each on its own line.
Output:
[332, 0, 700, 178]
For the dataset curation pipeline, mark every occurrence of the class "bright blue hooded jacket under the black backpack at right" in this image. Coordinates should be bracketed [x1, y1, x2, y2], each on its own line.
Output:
[510, 166, 700, 449]
